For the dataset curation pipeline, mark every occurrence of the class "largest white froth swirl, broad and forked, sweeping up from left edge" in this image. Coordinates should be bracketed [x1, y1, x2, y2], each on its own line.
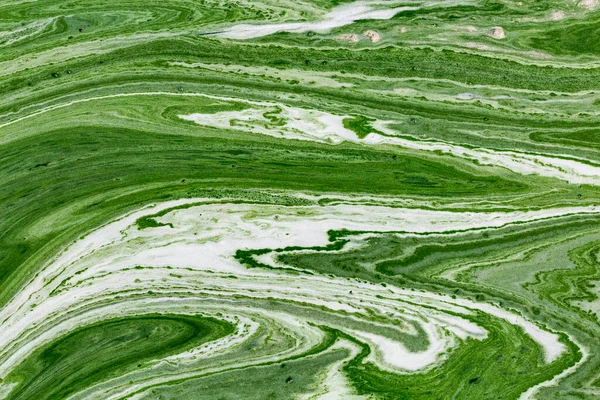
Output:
[0, 195, 576, 388]
